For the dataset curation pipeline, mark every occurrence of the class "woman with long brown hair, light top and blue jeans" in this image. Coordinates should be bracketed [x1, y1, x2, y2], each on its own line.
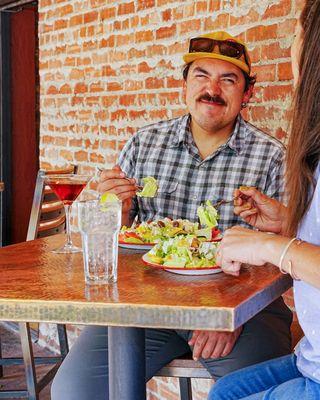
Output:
[209, 0, 320, 400]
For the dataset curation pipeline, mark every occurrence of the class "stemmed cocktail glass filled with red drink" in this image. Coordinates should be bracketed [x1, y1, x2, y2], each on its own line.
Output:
[45, 174, 92, 253]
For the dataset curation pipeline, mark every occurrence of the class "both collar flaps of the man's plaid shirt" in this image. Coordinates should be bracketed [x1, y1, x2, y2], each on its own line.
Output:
[168, 114, 248, 154]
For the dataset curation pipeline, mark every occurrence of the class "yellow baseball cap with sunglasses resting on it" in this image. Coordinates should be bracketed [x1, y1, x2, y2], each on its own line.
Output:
[183, 31, 251, 75]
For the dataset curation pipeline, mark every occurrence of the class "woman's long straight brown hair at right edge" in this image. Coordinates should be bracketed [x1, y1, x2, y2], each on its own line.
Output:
[286, 0, 320, 236]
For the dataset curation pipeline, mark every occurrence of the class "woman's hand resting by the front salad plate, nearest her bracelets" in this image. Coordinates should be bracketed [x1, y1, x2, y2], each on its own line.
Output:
[217, 226, 274, 276]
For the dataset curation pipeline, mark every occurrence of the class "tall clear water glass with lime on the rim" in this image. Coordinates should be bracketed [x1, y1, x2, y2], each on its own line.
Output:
[78, 200, 121, 284]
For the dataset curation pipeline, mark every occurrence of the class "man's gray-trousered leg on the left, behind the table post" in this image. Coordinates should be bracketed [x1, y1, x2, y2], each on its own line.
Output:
[51, 326, 190, 400]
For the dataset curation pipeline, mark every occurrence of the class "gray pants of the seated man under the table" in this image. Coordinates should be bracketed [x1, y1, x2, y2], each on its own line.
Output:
[51, 298, 292, 400]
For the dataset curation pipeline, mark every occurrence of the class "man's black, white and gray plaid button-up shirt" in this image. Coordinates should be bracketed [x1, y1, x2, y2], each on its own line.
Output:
[119, 115, 284, 230]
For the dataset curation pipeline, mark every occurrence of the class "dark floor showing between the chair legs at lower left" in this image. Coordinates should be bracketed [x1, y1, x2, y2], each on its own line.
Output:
[0, 322, 52, 400]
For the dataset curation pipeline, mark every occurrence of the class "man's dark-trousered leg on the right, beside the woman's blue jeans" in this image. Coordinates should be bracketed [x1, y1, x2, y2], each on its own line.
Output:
[179, 298, 292, 379]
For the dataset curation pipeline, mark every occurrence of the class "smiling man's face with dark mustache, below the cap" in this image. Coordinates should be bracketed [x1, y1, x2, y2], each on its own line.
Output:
[184, 58, 250, 133]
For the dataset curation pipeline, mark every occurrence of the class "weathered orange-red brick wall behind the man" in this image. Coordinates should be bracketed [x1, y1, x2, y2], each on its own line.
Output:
[39, 0, 303, 400]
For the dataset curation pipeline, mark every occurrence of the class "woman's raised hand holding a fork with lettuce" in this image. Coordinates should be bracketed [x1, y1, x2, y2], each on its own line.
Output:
[234, 187, 287, 233]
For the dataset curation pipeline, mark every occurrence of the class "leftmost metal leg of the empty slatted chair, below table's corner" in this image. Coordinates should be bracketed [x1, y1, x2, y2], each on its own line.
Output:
[19, 322, 39, 400]
